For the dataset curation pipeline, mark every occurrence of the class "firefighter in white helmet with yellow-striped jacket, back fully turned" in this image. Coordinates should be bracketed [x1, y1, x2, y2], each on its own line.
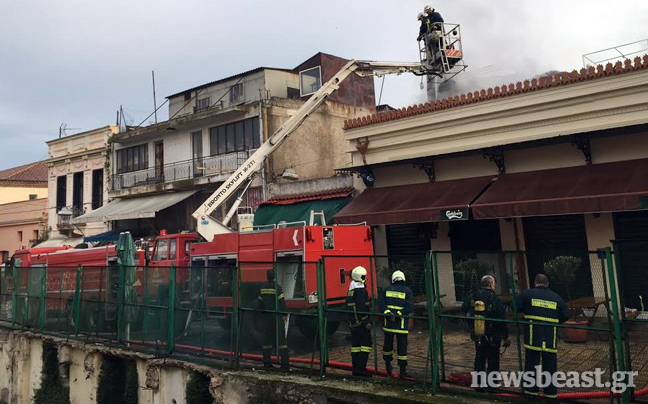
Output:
[378, 271, 414, 379]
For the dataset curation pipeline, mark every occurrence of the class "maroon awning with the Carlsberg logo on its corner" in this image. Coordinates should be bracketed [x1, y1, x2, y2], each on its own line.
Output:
[335, 176, 493, 224]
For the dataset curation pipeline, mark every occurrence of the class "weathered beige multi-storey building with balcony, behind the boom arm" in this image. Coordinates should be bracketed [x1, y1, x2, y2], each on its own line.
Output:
[73, 53, 375, 235]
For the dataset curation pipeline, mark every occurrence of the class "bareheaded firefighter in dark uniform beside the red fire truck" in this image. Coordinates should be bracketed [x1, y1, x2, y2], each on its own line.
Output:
[258, 269, 289, 371]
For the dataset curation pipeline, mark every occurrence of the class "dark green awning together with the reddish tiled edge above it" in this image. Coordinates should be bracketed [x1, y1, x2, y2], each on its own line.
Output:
[254, 188, 353, 226]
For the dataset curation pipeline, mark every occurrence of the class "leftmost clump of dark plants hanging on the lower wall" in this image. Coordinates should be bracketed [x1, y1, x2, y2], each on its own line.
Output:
[34, 342, 70, 404]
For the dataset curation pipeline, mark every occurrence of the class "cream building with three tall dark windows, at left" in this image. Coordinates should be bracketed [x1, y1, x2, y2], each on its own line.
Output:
[47, 126, 118, 244]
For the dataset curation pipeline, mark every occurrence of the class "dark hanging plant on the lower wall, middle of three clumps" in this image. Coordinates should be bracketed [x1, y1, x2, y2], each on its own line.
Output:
[97, 356, 138, 404]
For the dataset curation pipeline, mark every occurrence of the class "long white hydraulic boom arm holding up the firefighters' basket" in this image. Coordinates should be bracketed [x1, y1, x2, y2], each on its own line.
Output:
[193, 60, 430, 241]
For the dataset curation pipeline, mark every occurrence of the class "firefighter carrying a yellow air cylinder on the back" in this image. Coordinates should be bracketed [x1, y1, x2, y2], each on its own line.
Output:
[461, 275, 511, 386]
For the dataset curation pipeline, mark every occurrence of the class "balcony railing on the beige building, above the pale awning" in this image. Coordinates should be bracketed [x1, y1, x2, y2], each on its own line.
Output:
[111, 150, 254, 191]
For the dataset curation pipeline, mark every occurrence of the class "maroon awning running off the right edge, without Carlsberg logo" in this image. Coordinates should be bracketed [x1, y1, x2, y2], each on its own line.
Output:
[472, 159, 648, 219]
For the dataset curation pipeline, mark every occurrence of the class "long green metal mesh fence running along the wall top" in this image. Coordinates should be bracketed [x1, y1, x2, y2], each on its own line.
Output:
[0, 249, 648, 402]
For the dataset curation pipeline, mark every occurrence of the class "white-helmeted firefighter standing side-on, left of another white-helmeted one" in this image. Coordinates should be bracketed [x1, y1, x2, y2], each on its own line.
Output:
[346, 267, 372, 377]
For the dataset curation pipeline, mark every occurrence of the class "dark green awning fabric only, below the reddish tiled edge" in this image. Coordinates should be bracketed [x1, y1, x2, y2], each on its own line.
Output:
[254, 197, 353, 226]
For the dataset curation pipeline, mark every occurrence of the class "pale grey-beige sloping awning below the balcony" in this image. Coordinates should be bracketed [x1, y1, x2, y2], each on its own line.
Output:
[72, 191, 196, 223]
